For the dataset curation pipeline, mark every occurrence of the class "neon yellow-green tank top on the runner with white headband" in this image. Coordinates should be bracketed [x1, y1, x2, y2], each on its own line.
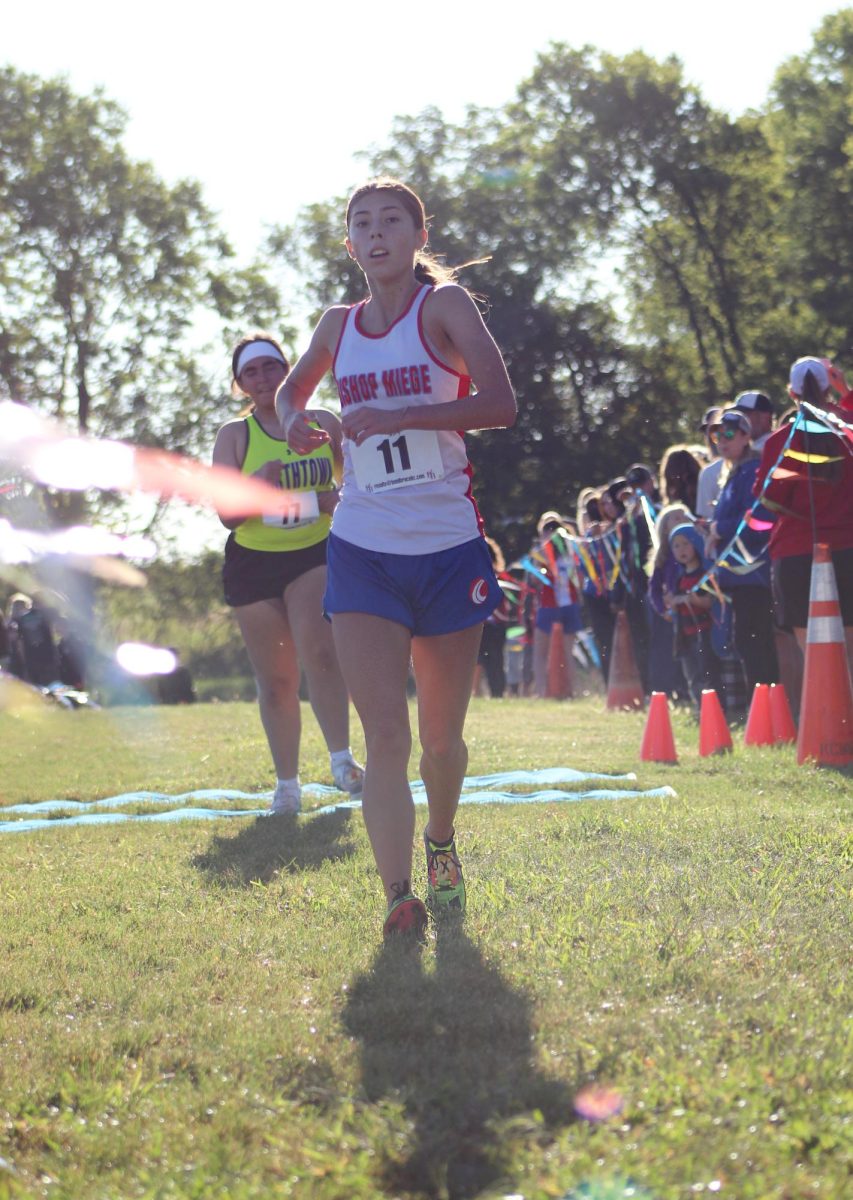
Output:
[234, 414, 335, 551]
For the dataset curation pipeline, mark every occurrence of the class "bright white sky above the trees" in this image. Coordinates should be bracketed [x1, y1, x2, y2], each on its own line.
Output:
[0, 0, 843, 259]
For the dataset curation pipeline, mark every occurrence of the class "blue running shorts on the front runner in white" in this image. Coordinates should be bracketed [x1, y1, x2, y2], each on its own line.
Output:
[323, 534, 503, 637]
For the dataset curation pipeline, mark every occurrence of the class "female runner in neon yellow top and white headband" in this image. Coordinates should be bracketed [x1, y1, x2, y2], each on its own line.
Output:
[214, 334, 364, 812]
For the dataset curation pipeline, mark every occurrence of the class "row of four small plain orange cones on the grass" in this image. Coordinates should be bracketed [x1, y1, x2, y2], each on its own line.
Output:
[639, 683, 797, 764]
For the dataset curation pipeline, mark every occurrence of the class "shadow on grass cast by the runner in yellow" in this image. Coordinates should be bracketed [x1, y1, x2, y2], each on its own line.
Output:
[192, 809, 354, 888]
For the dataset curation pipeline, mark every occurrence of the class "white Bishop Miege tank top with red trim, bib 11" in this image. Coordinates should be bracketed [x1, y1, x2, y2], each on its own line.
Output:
[332, 284, 482, 554]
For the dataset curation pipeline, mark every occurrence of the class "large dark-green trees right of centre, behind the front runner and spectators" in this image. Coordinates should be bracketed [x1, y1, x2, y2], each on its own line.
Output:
[274, 10, 853, 548]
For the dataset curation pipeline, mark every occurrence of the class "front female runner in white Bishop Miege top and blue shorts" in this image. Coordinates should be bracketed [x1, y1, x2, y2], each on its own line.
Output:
[276, 179, 516, 936]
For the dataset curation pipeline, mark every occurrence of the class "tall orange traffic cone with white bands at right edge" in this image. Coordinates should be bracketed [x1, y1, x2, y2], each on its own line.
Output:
[797, 544, 853, 767]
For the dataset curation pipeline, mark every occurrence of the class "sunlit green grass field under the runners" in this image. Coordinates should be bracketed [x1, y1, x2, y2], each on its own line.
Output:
[0, 700, 853, 1200]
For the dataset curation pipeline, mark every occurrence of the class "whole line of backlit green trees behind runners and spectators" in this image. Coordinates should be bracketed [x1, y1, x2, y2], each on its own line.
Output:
[0, 8, 853, 541]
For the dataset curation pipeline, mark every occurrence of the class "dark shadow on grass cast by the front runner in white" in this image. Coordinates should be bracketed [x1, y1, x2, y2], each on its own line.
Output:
[343, 928, 573, 1200]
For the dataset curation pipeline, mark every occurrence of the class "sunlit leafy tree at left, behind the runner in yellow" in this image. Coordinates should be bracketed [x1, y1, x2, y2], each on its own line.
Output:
[0, 67, 282, 451]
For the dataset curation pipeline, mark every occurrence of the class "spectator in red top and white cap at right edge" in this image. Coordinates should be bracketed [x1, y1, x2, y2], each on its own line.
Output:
[755, 356, 853, 672]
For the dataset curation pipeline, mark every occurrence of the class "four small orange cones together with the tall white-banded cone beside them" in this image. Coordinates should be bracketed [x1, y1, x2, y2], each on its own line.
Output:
[639, 544, 853, 766]
